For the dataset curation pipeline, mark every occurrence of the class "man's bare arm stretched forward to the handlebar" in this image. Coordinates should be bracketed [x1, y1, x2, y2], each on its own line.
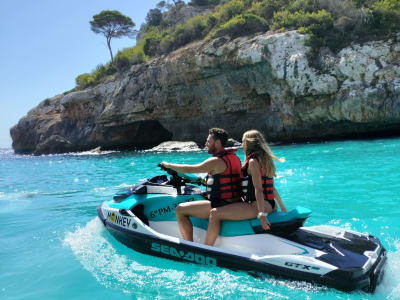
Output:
[161, 157, 226, 174]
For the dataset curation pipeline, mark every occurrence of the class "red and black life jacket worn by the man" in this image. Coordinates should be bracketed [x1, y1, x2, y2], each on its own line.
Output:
[206, 149, 242, 202]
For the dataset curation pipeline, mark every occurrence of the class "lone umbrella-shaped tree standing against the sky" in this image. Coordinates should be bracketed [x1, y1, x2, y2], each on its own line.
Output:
[90, 10, 136, 61]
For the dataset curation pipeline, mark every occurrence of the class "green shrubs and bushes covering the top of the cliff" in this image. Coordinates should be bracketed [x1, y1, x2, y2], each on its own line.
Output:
[76, 0, 400, 88]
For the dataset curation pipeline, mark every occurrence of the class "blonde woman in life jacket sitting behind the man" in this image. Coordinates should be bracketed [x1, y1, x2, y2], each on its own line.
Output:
[205, 130, 287, 245]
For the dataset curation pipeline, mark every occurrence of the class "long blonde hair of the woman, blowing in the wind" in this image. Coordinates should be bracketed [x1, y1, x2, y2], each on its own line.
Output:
[243, 129, 285, 177]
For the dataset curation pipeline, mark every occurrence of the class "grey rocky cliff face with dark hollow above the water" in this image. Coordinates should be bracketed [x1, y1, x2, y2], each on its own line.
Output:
[11, 31, 400, 154]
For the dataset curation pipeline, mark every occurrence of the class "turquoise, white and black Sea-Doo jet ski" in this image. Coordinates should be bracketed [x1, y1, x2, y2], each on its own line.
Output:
[97, 165, 386, 292]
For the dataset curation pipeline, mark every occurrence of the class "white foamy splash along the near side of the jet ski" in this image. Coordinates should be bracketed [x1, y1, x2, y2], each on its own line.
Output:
[63, 218, 314, 299]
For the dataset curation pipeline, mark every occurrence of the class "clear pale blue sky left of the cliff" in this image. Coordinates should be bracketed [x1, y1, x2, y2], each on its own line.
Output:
[0, 0, 166, 147]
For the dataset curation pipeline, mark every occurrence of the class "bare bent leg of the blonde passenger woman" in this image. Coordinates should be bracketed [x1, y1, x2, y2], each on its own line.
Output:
[204, 201, 272, 246]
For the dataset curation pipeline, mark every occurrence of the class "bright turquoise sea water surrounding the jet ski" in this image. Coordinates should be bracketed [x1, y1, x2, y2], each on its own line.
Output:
[0, 138, 400, 299]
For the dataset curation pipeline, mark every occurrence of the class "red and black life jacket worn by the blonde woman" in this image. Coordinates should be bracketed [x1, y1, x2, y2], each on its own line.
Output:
[242, 152, 274, 202]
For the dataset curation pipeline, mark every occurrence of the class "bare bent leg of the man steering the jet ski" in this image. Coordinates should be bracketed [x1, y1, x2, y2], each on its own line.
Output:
[175, 200, 211, 242]
